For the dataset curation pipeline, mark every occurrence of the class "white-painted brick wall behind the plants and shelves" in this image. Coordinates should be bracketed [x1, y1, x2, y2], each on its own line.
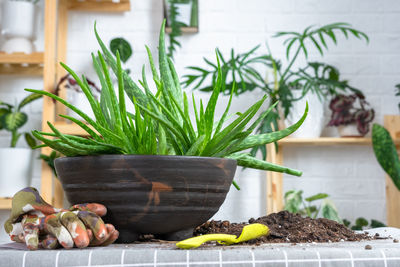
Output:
[0, 0, 400, 243]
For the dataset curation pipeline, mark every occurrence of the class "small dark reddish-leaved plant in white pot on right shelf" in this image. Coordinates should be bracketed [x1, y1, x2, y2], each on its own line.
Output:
[328, 93, 375, 137]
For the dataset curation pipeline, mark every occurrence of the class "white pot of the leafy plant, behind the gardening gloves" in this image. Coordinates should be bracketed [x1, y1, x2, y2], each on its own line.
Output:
[0, 148, 32, 197]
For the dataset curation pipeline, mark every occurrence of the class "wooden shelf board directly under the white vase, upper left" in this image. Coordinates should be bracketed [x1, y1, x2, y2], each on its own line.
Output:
[0, 52, 44, 75]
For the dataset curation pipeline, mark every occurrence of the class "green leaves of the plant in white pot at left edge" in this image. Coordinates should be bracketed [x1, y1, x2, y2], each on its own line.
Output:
[0, 94, 42, 147]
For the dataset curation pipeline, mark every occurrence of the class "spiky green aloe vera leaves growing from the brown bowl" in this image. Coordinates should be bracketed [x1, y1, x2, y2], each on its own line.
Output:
[26, 21, 308, 188]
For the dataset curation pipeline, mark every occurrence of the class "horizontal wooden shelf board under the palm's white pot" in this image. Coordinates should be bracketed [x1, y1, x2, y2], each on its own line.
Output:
[278, 137, 372, 146]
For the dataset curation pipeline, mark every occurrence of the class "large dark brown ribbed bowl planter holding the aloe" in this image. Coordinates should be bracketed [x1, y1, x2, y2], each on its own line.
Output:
[55, 155, 236, 242]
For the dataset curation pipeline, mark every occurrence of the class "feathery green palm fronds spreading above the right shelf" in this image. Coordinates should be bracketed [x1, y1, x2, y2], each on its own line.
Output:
[183, 23, 369, 159]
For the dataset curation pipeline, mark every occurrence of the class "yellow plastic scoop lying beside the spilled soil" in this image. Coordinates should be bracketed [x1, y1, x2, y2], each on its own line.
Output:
[176, 223, 269, 249]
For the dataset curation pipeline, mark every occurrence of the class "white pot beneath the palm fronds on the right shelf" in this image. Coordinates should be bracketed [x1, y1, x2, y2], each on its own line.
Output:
[285, 90, 325, 138]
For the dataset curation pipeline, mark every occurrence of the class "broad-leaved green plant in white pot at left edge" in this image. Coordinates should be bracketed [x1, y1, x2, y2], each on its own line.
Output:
[0, 94, 41, 197]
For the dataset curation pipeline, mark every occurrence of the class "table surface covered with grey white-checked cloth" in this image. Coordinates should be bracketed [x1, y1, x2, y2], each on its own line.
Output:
[0, 228, 400, 267]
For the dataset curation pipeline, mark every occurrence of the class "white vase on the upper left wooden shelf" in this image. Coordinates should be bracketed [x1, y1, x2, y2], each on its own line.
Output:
[1, 0, 35, 54]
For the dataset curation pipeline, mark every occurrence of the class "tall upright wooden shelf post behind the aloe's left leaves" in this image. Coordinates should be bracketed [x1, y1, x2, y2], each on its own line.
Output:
[41, 0, 57, 203]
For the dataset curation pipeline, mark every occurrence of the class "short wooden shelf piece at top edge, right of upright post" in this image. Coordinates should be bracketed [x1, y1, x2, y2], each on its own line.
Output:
[68, 0, 131, 12]
